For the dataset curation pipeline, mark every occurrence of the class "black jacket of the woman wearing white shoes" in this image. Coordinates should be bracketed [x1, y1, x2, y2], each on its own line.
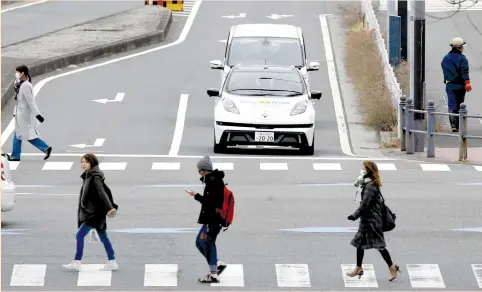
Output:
[77, 166, 113, 231]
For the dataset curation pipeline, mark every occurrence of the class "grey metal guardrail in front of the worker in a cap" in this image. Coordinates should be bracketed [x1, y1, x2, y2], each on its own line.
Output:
[398, 96, 482, 162]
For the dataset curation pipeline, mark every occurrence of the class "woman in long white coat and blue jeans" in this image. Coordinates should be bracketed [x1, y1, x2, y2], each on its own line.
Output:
[10, 65, 52, 161]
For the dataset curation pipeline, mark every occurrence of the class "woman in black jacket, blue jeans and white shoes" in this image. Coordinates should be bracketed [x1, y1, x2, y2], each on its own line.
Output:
[63, 153, 119, 271]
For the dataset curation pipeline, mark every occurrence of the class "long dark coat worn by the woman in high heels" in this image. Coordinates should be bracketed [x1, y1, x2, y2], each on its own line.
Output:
[351, 181, 386, 249]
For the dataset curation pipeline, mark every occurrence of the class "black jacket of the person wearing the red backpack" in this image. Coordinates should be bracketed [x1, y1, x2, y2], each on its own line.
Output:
[194, 169, 224, 224]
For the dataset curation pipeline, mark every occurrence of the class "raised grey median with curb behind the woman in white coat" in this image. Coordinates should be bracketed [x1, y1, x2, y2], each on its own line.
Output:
[2, 5, 172, 109]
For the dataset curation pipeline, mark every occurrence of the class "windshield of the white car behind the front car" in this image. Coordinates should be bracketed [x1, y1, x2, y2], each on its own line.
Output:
[227, 37, 304, 68]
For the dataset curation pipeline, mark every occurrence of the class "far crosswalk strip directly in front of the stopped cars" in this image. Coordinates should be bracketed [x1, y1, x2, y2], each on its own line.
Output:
[9, 158, 482, 173]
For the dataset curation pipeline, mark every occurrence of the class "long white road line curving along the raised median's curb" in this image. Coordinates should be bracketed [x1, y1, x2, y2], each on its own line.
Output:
[1, 1, 202, 146]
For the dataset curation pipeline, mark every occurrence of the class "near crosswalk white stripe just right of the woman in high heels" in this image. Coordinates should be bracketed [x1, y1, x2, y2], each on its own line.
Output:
[407, 264, 445, 288]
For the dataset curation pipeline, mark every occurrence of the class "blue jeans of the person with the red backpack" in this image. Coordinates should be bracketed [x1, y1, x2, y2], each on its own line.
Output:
[196, 224, 221, 272]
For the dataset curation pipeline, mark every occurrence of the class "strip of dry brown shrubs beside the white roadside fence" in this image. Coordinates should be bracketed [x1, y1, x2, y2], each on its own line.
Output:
[340, 4, 397, 131]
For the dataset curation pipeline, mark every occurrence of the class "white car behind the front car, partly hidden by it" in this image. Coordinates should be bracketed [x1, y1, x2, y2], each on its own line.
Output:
[210, 24, 320, 90]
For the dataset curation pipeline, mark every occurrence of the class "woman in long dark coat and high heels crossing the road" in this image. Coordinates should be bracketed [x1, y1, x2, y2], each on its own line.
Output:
[347, 161, 400, 281]
